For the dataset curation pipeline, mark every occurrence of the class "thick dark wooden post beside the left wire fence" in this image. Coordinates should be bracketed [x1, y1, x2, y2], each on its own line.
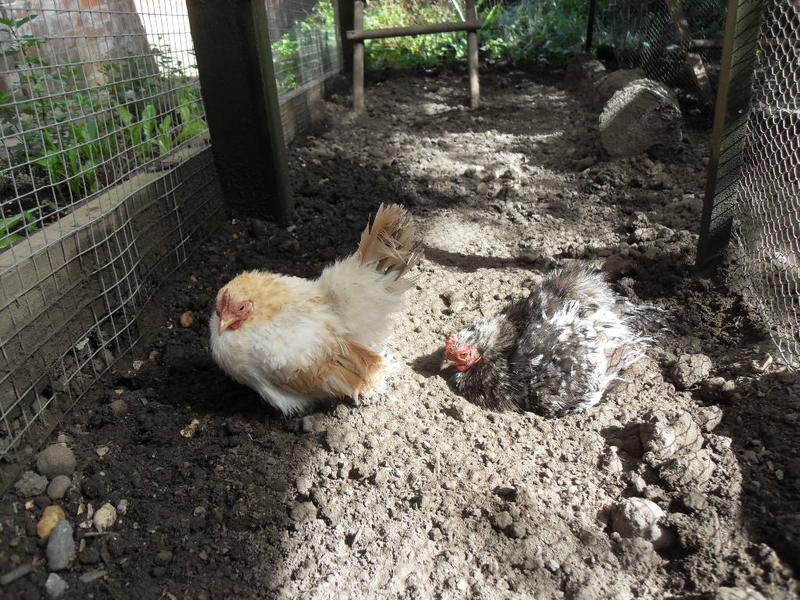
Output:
[187, 0, 293, 223]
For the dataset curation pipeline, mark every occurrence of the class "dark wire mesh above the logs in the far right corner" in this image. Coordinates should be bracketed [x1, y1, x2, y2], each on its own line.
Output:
[595, 0, 726, 101]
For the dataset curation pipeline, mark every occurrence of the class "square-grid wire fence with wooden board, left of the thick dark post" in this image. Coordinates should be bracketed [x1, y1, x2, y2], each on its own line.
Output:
[0, 0, 221, 475]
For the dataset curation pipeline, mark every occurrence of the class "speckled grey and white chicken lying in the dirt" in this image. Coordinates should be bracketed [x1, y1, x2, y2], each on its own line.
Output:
[442, 267, 658, 417]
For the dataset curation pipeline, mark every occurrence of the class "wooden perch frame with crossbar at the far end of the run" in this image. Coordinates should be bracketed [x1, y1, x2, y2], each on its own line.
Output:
[345, 0, 481, 113]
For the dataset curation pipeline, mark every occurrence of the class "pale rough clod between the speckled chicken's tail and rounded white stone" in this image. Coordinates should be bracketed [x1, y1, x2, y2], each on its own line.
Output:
[639, 410, 704, 466]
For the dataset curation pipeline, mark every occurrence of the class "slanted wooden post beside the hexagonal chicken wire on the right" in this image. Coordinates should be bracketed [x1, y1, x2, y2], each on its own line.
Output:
[696, 0, 764, 268]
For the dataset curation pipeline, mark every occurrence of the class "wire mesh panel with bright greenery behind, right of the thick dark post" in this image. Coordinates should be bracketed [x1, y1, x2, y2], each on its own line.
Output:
[267, 0, 341, 98]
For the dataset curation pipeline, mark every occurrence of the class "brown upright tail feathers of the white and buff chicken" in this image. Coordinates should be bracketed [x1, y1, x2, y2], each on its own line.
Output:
[358, 204, 422, 291]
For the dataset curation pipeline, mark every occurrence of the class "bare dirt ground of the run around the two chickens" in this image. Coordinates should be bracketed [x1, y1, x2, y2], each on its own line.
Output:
[0, 67, 800, 600]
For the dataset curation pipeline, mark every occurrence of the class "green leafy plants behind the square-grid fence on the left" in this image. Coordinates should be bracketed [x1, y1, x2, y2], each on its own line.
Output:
[0, 14, 207, 247]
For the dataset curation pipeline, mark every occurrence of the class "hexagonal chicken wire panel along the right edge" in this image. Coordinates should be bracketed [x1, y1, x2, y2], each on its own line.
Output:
[731, 2, 800, 368]
